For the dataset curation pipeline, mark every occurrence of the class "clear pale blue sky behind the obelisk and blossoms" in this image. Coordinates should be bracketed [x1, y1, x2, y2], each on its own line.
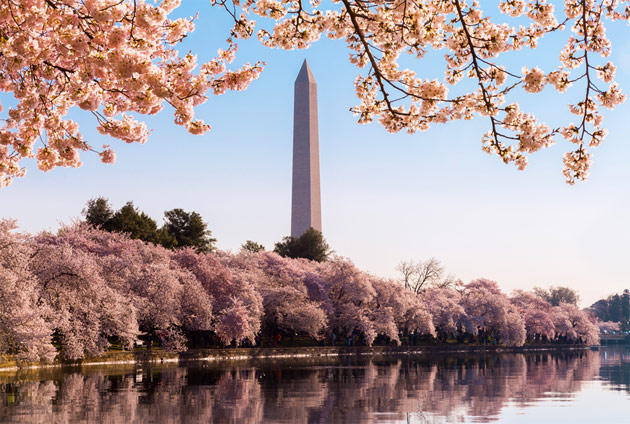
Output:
[0, 1, 630, 306]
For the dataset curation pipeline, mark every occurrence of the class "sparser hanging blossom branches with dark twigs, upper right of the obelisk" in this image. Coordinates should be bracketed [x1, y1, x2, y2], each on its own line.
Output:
[213, 0, 630, 184]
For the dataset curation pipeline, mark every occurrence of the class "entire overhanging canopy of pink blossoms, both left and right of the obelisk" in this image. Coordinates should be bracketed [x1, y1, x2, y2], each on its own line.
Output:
[0, 0, 630, 186]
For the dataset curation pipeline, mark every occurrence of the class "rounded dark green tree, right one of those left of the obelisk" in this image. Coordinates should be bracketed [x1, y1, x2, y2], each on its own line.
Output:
[163, 208, 217, 252]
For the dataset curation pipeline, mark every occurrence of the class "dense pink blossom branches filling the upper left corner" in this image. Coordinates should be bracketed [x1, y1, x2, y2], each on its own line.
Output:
[0, 0, 262, 187]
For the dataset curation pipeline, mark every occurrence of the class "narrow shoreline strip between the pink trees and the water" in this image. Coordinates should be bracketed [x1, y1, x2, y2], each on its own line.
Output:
[0, 344, 599, 373]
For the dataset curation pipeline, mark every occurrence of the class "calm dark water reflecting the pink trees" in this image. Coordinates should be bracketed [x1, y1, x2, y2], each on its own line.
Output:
[0, 347, 630, 424]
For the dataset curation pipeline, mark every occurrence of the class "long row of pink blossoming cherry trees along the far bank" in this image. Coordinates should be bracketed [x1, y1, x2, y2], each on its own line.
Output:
[0, 220, 599, 360]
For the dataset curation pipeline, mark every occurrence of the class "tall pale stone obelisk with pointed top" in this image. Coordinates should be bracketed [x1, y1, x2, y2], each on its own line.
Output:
[291, 60, 322, 237]
